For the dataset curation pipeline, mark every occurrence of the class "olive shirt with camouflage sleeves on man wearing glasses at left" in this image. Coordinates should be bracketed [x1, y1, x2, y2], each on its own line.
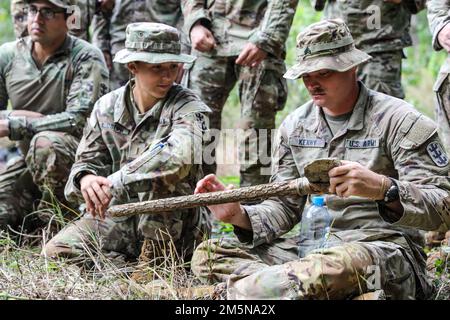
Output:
[0, 36, 108, 140]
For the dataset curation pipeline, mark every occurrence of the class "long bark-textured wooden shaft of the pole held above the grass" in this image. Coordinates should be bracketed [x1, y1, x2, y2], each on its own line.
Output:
[108, 178, 319, 217]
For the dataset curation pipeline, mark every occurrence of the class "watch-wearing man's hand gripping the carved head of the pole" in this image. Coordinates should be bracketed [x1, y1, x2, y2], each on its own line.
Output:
[328, 160, 391, 200]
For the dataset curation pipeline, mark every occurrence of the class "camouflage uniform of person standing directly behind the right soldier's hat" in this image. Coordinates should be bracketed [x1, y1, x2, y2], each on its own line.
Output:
[312, 0, 426, 99]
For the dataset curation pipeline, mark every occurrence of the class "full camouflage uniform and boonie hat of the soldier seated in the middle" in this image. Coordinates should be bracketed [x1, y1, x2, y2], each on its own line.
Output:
[44, 23, 210, 258]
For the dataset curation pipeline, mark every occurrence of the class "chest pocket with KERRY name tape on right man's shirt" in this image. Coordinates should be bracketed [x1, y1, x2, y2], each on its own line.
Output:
[288, 136, 328, 175]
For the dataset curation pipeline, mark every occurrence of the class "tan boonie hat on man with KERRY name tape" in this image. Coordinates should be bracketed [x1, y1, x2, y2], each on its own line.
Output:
[284, 19, 371, 79]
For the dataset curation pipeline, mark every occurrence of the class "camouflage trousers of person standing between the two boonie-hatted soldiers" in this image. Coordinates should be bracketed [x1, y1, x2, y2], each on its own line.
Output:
[183, 56, 287, 186]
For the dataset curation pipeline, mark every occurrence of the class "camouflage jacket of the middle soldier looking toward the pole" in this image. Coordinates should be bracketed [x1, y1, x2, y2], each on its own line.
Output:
[65, 83, 210, 203]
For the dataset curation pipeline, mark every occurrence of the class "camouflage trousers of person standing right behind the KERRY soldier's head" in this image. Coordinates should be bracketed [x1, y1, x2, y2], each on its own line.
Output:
[358, 50, 405, 99]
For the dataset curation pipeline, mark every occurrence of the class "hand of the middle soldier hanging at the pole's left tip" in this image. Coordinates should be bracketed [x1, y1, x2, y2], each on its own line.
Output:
[80, 174, 112, 219]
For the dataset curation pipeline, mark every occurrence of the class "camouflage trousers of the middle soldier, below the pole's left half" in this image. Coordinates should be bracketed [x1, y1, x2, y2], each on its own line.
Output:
[42, 210, 211, 259]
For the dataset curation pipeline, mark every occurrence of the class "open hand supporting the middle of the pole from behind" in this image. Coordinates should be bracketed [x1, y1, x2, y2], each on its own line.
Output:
[194, 174, 251, 230]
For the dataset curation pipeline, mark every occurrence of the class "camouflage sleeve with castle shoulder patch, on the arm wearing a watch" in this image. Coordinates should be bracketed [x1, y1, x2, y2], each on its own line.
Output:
[380, 113, 450, 230]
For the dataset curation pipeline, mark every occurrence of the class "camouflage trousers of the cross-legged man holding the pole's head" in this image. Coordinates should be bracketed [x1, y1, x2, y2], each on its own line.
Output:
[191, 238, 416, 300]
